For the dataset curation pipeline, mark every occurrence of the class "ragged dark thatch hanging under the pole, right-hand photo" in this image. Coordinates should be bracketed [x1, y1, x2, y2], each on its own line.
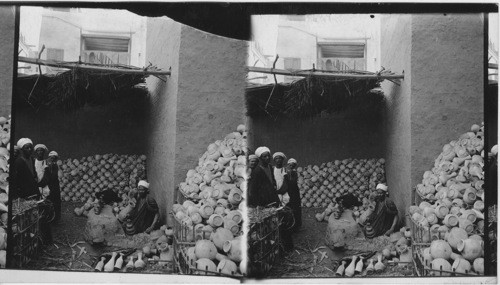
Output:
[246, 73, 384, 119]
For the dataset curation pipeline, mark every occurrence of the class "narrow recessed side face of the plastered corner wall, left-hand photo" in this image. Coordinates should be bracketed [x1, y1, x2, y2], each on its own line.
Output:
[146, 18, 181, 220]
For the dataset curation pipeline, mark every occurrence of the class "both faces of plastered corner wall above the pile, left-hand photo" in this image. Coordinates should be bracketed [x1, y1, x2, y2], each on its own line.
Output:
[146, 18, 247, 222]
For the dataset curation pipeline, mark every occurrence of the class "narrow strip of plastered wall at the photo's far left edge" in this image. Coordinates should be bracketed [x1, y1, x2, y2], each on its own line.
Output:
[0, 6, 15, 117]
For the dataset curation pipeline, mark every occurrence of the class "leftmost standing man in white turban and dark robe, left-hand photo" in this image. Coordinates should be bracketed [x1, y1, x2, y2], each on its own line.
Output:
[11, 138, 40, 199]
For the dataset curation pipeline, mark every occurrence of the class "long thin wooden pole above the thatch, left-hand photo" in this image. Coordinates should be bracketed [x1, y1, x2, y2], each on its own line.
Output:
[18, 56, 171, 76]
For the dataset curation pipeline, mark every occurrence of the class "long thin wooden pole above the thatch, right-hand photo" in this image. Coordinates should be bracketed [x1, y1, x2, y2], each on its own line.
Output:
[247, 66, 404, 79]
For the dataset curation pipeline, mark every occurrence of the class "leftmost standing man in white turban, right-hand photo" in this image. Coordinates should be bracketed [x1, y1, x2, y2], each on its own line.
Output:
[248, 146, 280, 207]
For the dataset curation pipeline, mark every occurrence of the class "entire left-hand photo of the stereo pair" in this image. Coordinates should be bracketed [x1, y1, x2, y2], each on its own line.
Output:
[4, 6, 248, 281]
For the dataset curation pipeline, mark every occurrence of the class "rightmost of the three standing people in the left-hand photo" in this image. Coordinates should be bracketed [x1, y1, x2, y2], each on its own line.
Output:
[38, 151, 61, 222]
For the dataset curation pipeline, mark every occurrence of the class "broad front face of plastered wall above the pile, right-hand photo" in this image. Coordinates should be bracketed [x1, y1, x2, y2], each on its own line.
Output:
[411, 14, 484, 189]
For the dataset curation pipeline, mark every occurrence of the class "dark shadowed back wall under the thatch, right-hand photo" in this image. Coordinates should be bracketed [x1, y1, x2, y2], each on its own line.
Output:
[249, 107, 385, 165]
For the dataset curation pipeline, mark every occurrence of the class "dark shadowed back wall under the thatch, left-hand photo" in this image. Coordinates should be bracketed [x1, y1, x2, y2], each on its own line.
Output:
[15, 94, 147, 159]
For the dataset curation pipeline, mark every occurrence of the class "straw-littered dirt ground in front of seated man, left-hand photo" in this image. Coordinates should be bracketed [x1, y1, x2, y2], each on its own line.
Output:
[23, 202, 173, 274]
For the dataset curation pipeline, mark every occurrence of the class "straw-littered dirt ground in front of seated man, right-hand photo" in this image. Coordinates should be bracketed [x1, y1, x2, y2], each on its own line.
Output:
[268, 208, 413, 278]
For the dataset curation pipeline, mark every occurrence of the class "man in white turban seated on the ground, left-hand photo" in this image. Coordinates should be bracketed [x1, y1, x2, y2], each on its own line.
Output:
[124, 180, 160, 235]
